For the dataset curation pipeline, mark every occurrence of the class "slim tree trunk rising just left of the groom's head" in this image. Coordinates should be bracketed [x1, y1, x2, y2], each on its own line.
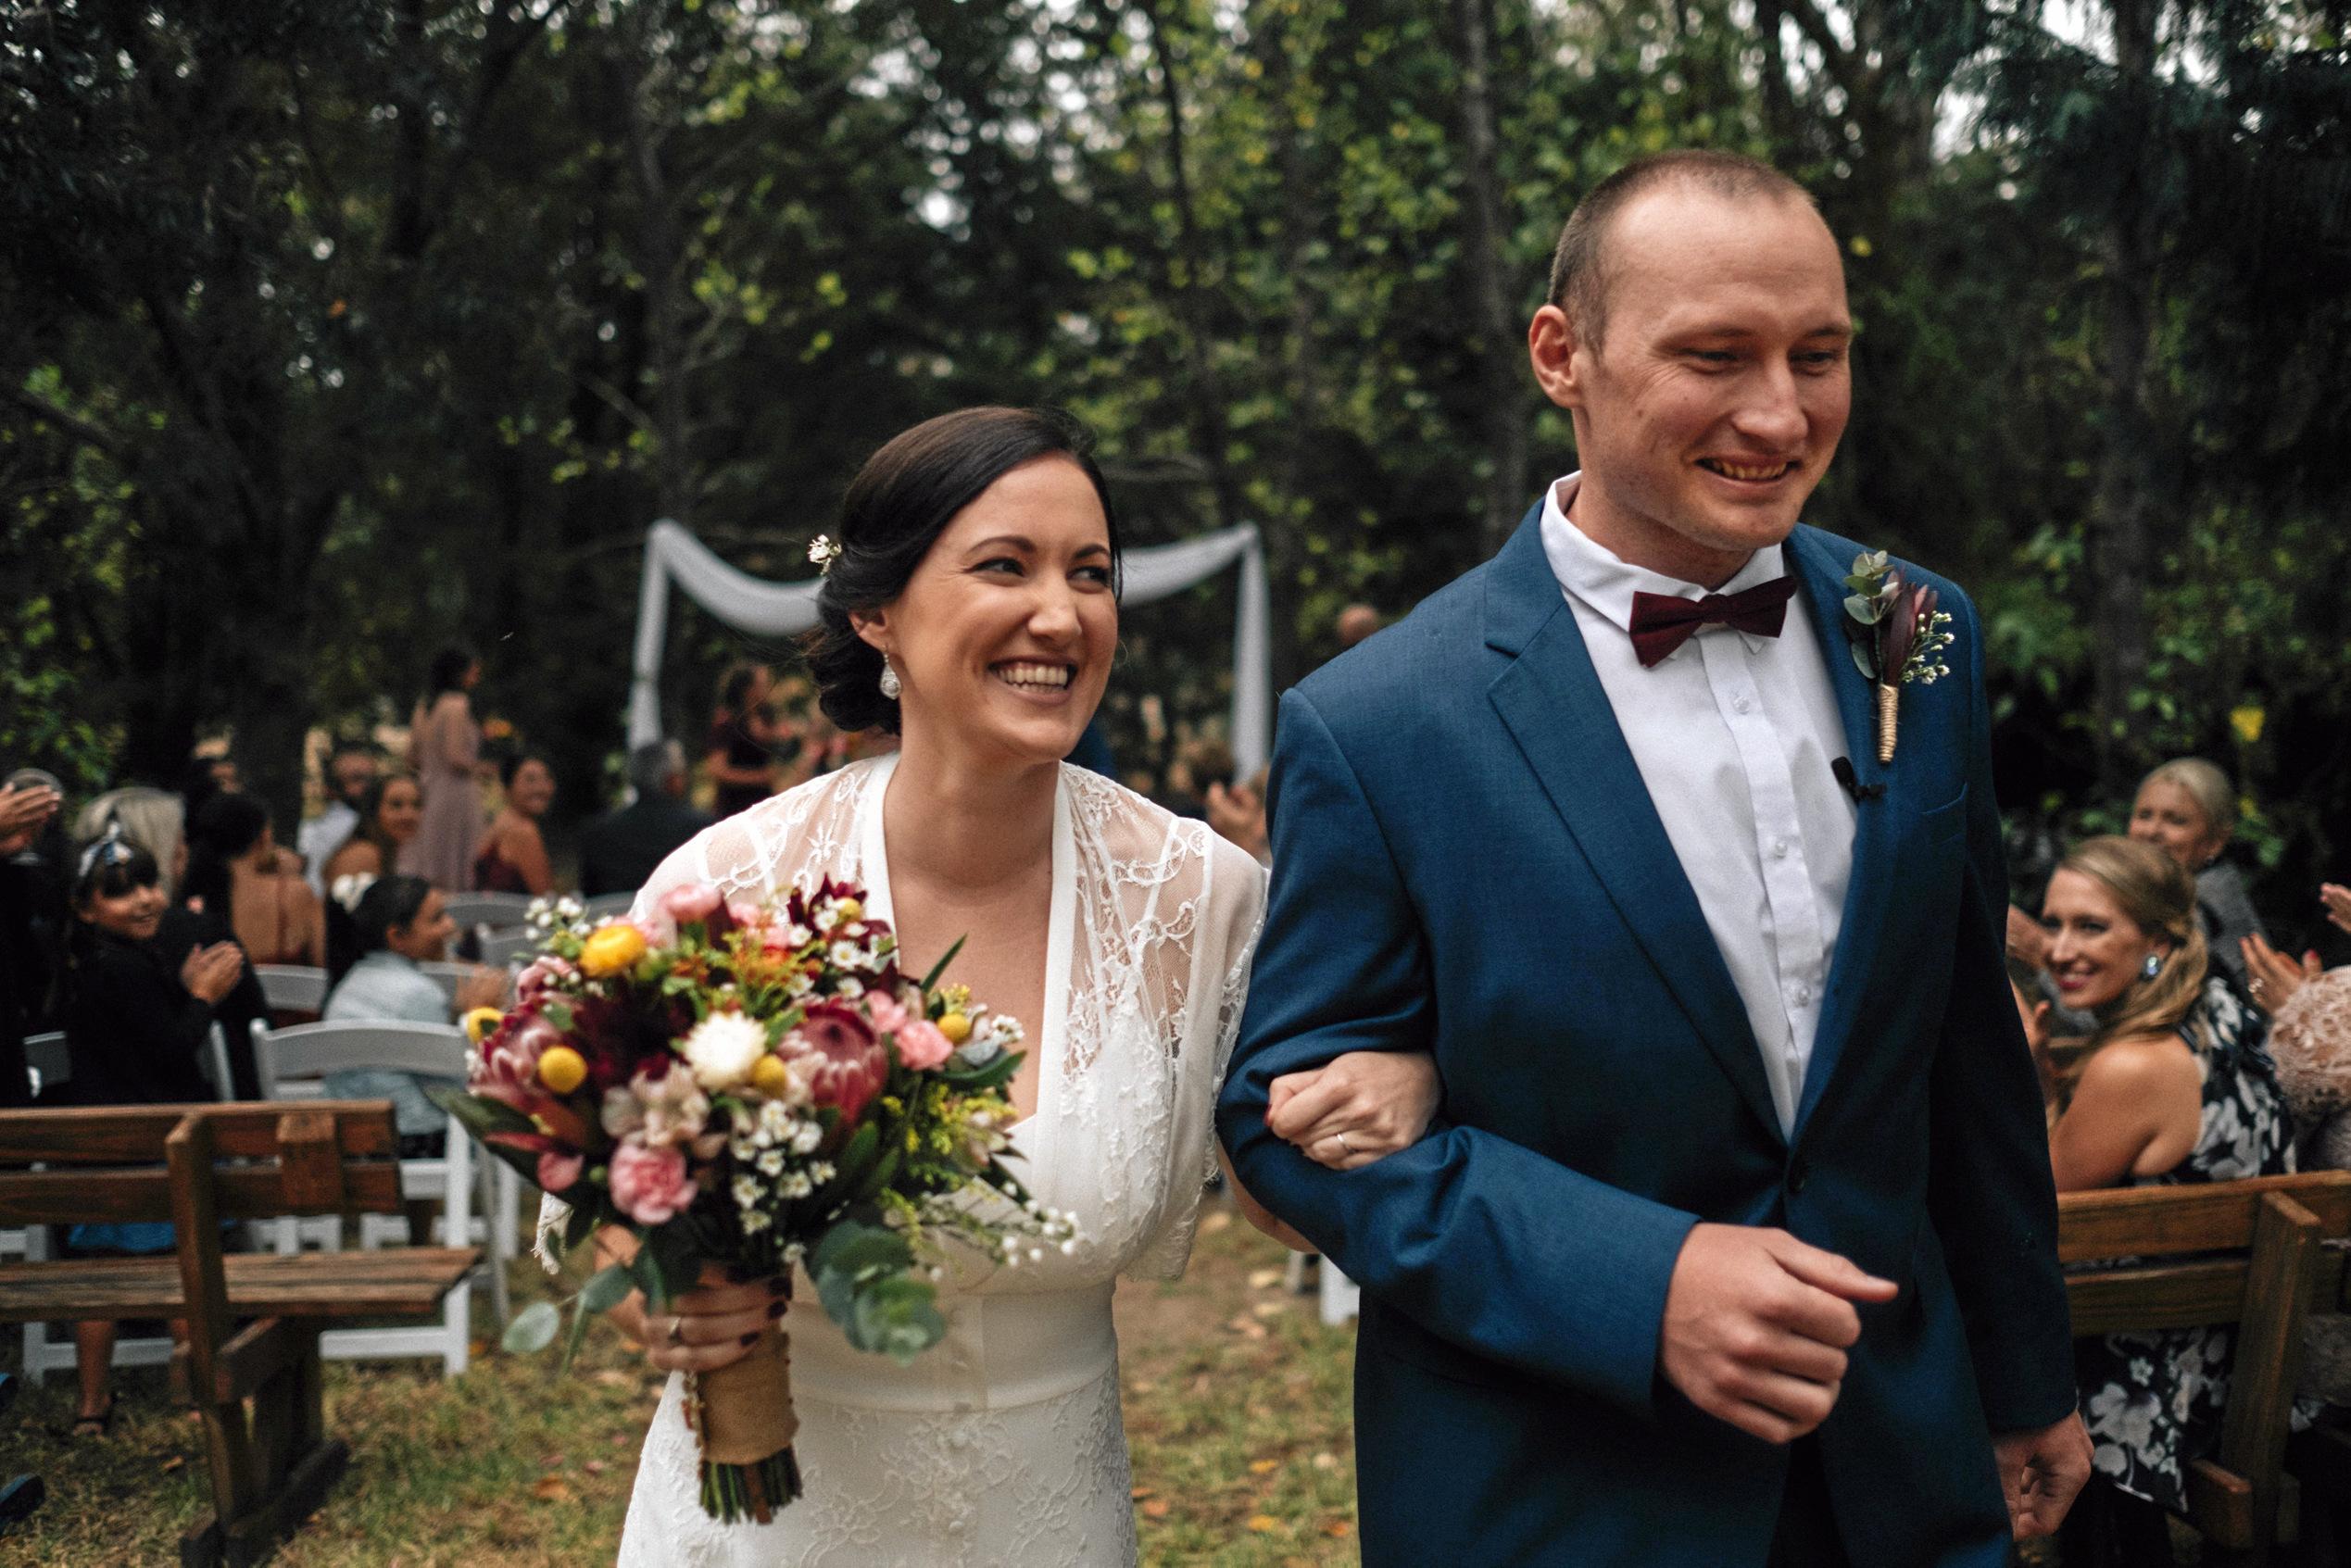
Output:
[1452, 0, 1526, 555]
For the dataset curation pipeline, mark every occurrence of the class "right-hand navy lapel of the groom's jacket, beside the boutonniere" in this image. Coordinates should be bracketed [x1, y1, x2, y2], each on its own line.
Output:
[1787, 529, 1902, 1138]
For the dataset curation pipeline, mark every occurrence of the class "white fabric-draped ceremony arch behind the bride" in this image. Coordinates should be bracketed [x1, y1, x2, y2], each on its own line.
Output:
[628, 517, 1275, 778]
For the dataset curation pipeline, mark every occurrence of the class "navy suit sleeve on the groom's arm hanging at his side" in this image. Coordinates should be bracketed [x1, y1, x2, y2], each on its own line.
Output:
[1928, 587, 2076, 1432]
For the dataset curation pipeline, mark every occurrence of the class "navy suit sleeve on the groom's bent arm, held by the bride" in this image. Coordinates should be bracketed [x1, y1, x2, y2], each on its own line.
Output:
[1218, 691, 1695, 1415]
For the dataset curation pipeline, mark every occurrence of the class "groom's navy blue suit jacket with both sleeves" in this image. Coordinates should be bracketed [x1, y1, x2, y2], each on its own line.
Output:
[1218, 508, 2074, 1568]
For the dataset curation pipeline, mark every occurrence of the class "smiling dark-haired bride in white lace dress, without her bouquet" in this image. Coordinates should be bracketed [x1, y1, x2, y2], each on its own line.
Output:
[597, 409, 1437, 1568]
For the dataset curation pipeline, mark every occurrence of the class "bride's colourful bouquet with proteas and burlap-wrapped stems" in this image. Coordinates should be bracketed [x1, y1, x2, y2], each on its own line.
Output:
[435, 882, 1075, 1524]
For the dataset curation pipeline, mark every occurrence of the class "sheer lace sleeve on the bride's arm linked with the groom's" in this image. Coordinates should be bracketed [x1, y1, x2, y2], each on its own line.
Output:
[1126, 834, 1264, 1279]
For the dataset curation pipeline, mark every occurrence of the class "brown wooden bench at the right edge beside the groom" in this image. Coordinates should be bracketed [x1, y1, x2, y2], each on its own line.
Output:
[2057, 1171, 2351, 1563]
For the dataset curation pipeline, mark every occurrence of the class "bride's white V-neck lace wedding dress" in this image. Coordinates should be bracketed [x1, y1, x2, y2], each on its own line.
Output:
[597, 757, 1264, 1568]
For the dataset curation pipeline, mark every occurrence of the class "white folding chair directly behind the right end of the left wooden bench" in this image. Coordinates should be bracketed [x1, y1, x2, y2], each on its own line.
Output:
[254, 1022, 506, 1377]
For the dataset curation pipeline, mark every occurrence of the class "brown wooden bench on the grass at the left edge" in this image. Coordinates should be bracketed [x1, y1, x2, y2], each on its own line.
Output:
[0, 1100, 480, 1568]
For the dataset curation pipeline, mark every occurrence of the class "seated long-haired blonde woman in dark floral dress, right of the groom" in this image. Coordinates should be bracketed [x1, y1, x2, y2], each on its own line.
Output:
[2041, 837, 2294, 1563]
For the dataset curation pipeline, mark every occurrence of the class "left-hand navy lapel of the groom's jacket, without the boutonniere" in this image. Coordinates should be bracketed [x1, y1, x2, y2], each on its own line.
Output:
[1486, 503, 1779, 1135]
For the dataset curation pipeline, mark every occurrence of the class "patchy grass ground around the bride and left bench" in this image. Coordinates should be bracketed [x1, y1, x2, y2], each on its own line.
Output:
[0, 1206, 1356, 1568]
